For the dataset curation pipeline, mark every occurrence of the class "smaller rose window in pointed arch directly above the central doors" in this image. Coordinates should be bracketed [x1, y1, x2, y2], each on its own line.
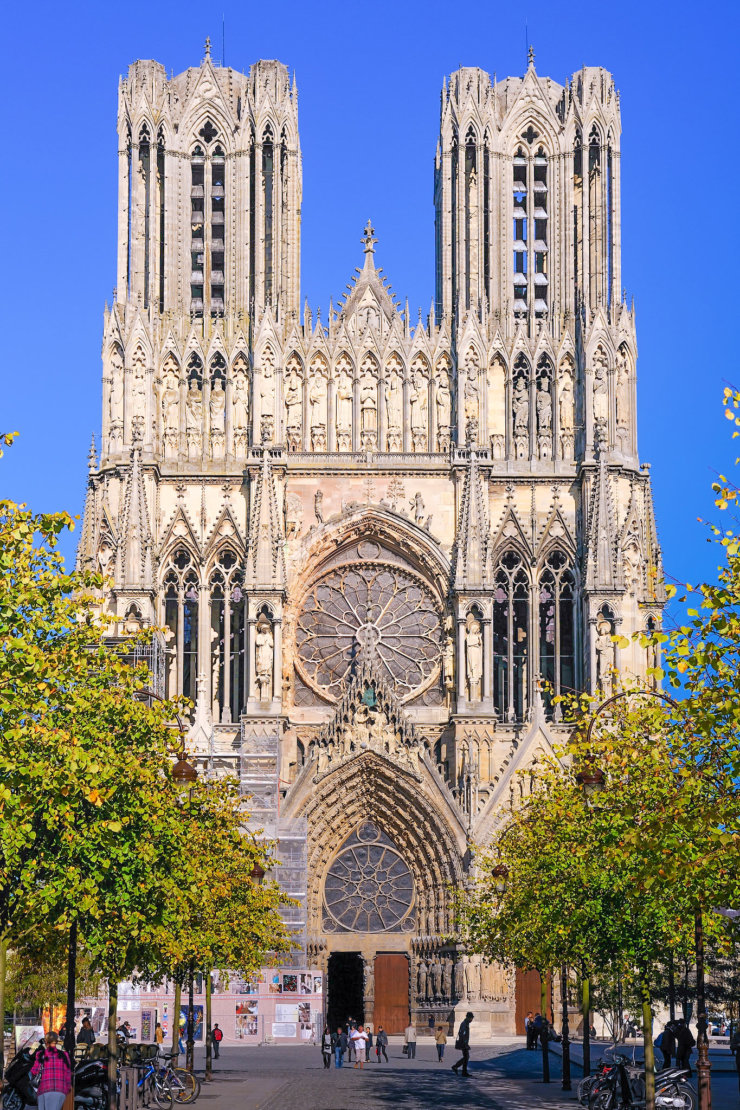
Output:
[324, 821, 414, 932]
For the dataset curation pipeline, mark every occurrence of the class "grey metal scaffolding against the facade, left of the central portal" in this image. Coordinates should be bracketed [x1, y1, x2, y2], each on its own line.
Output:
[240, 717, 307, 968]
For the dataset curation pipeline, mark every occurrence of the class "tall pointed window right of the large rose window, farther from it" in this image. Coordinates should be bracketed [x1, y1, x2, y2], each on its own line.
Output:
[538, 548, 576, 708]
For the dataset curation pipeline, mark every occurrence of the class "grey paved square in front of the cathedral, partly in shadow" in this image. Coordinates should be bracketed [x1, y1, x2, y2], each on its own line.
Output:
[188, 1043, 740, 1110]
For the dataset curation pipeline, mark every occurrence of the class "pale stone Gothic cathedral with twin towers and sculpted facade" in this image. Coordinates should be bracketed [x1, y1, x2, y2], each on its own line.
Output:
[78, 44, 663, 1032]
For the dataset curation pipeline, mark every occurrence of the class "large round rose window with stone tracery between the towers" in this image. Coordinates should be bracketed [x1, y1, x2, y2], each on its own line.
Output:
[296, 563, 442, 698]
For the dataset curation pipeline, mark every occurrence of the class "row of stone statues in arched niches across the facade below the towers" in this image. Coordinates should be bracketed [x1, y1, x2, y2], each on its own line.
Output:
[109, 347, 631, 458]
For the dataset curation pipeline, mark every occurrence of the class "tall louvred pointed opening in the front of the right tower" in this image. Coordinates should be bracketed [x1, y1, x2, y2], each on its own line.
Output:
[511, 140, 549, 316]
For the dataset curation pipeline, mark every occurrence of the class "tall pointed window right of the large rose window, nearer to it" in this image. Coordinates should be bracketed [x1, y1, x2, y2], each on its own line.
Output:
[493, 549, 529, 722]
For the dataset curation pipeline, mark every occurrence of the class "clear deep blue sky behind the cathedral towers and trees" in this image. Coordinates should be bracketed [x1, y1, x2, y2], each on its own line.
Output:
[0, 0, 740, 626]
